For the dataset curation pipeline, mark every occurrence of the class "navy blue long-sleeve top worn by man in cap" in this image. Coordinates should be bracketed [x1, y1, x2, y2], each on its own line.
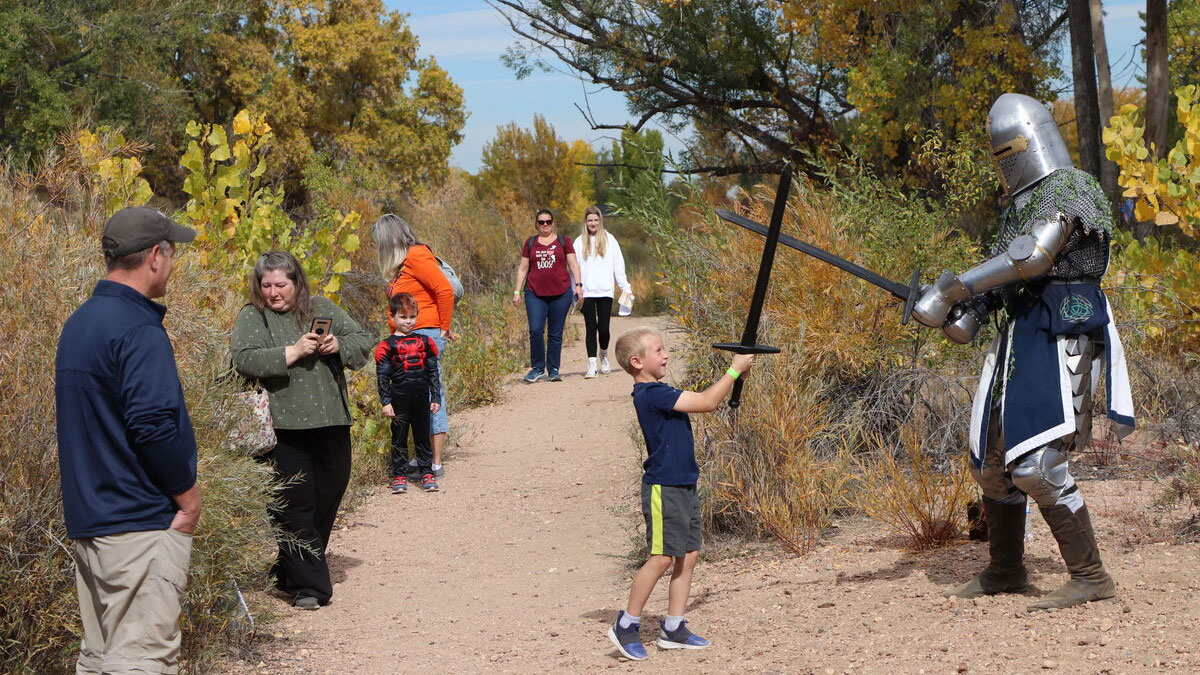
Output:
[54, 280, 196, 539]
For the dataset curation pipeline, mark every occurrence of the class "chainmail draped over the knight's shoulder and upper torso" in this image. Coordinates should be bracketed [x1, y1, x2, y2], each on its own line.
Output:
[991, 168, 1112, 280]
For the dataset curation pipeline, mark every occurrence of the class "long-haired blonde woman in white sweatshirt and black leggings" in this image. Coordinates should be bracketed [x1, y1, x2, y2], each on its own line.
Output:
[575, 201, 634, 377]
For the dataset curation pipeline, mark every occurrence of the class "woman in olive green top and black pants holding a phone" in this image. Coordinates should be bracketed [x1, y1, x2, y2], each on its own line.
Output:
[232, 251, 376, 609]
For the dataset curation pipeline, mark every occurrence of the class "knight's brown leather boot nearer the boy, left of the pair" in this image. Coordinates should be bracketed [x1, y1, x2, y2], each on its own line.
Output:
[944, 497, 1028, 598]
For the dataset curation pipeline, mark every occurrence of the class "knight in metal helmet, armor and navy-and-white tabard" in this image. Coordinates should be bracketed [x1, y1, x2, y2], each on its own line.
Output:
[912, 94, 1134, 611]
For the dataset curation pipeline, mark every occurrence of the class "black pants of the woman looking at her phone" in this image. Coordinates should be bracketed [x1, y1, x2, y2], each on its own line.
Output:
[266, 416, 350, 604]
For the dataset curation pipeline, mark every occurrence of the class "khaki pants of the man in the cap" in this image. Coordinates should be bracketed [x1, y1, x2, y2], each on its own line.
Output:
[73, 530, 192, 675]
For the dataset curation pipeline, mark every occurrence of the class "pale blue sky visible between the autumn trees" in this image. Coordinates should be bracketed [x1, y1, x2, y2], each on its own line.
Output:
[384, 0, 1146, 173]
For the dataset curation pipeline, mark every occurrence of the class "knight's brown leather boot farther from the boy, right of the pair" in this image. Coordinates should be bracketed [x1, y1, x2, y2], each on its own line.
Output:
[1027, 506, 1117, 611]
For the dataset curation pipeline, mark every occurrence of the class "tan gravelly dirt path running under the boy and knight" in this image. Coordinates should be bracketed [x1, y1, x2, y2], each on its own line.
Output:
[227, 317, 1200, 675]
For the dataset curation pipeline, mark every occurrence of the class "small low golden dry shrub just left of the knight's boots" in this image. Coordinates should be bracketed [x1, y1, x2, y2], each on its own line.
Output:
[854, 424, 977, 551]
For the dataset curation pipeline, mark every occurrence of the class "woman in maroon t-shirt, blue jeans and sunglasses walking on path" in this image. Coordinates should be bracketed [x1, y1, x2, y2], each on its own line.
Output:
[512, 209, 583, 382]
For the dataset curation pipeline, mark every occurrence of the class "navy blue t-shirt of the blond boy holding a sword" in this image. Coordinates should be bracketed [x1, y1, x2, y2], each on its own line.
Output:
[634, 382, 700, 485]
